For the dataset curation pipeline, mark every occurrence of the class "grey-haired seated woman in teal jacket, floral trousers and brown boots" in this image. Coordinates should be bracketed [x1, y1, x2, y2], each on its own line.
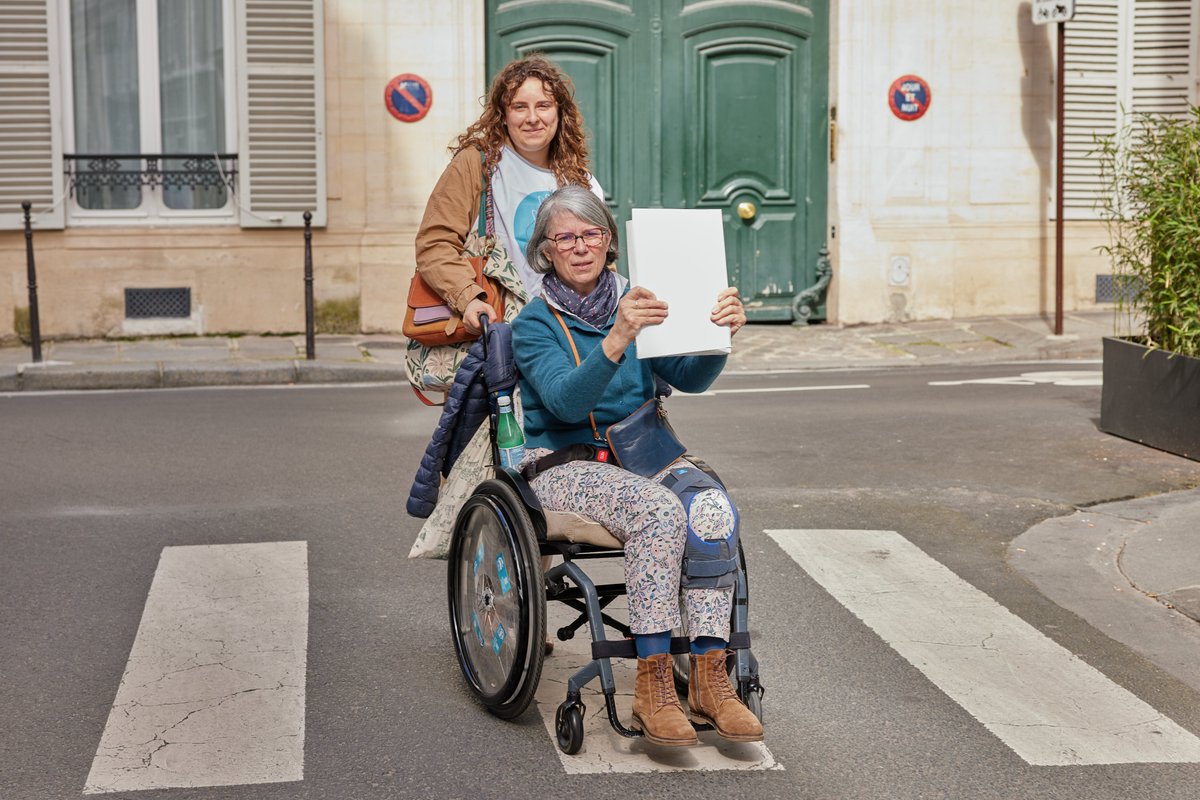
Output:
[512, 186, 762, 746]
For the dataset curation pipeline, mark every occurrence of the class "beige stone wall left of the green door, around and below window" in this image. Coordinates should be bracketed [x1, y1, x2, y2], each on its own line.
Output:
[0, 0, 486, 339]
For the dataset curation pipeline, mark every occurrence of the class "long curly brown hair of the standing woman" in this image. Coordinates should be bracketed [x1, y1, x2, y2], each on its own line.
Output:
[450, 53, 589, 186]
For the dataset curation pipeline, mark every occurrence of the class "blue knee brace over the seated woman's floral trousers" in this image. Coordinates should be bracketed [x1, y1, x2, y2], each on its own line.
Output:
[662, 467, 738, 589]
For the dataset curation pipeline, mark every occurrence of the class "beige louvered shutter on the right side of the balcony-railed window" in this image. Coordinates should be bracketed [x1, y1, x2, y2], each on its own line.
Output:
[238, 0, 325, 228]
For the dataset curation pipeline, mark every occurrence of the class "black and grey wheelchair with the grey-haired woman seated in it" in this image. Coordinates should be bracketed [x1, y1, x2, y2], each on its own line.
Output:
[446, 331, 764, 754]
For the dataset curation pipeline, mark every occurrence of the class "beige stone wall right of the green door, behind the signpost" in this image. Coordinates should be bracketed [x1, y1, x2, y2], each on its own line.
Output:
[829, 0, 1109, 324]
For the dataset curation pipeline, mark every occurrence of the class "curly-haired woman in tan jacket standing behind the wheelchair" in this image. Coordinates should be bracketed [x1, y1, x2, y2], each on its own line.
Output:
[406, 53, 602, 558]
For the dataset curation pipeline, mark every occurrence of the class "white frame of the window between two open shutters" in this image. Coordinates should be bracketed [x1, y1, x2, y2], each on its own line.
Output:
[56, 0, 241, 227]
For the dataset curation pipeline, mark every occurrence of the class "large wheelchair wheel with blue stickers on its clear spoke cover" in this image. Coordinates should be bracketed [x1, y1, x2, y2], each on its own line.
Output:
[446, 480, 546, 720]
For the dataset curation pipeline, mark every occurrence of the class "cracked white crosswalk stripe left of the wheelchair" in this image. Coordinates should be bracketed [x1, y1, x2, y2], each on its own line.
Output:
[84, 542, 308, 794]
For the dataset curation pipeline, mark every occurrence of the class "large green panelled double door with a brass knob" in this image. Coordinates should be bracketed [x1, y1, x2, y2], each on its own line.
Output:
[487, 0, 829, 320]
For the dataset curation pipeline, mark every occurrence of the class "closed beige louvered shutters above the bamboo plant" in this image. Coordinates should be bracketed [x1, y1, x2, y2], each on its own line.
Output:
[1063, 0, 1195, 219]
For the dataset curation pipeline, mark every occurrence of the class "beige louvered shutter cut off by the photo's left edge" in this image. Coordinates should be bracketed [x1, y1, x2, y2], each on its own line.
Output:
[0, 0, 64, 230]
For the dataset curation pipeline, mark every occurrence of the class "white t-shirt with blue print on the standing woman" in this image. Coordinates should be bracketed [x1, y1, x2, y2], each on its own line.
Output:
[476, 146, 604, 297]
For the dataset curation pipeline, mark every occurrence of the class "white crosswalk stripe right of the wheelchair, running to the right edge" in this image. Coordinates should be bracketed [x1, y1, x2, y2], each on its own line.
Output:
[767, 530, 1200, 766]
